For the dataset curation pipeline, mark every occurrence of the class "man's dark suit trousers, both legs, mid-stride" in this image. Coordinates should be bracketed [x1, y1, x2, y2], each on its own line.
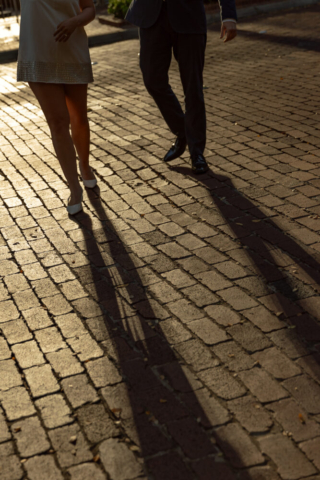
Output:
[140, 2, 207, 156]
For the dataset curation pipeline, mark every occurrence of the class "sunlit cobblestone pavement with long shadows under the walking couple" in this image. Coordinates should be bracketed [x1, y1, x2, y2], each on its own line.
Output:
[0, 8, 320, 480]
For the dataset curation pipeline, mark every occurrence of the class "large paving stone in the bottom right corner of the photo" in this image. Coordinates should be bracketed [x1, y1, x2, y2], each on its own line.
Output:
[259, 433, 317, 480]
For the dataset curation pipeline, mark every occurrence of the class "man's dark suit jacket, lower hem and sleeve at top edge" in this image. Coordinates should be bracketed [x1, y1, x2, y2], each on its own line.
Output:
[126, 0, 237, 33]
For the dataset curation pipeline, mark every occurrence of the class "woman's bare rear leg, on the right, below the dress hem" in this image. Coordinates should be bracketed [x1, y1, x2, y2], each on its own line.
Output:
[65, 85, 95, 180]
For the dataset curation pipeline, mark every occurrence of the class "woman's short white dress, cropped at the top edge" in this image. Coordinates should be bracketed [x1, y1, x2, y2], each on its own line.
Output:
[17, 0, 93, 84]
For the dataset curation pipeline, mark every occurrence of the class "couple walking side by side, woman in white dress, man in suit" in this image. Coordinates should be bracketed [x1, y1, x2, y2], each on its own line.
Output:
[17, 0, 237, 215]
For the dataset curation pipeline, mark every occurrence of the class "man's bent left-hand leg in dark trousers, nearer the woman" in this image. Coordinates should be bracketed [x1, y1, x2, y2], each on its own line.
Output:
[140, 5, 185, 137]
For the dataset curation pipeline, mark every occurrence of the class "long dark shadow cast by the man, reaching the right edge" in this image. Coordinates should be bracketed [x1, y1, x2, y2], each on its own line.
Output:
[172, 166, 320, 386]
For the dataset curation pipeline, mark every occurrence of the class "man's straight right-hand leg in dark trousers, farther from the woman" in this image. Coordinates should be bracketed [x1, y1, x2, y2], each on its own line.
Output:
[173, 33, 207, 158]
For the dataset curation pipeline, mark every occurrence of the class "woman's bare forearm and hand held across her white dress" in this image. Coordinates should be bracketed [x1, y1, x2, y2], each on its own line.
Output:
[54, 0, 96, 42]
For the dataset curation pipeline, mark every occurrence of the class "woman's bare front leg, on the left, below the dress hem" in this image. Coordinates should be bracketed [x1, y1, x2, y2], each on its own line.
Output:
[30, 82, 82, 205]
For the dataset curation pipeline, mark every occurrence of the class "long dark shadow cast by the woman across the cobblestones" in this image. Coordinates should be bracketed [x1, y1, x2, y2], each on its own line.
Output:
[75, 191, 246, 480]
